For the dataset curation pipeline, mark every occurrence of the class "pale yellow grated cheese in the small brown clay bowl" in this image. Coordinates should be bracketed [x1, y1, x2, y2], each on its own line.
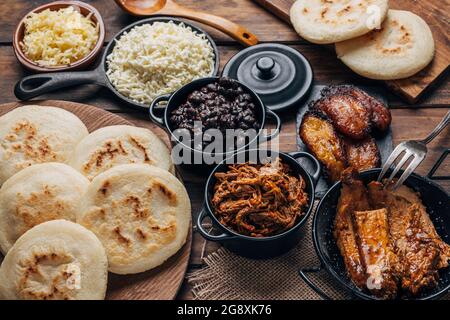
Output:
[21, 6, 99, 66]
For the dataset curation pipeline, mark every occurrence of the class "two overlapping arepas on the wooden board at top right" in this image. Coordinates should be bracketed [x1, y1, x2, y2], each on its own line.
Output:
[290, 0, 435, 80]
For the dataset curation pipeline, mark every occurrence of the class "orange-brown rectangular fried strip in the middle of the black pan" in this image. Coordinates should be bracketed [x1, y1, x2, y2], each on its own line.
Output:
[353, 209, 397, 299]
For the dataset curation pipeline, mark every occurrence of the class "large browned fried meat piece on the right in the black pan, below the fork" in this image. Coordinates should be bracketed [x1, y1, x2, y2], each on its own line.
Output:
[368, 182, 450, 295]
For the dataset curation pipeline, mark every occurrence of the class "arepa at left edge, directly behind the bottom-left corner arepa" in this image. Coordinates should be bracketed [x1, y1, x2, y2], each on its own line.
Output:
[0, 163, 89, 254]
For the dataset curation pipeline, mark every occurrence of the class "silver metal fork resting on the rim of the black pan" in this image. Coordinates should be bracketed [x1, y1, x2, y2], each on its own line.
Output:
[378, 111, 450, 190]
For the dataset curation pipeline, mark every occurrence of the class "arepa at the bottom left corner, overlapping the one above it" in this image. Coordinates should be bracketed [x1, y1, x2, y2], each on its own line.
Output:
[0, 220, 108, 300]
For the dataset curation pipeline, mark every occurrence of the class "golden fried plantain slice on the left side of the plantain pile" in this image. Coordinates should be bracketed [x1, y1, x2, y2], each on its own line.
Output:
[300, 112, 347, 181]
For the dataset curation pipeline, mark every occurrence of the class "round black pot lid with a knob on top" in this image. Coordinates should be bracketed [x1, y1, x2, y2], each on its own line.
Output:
[222, 43, 313, 111]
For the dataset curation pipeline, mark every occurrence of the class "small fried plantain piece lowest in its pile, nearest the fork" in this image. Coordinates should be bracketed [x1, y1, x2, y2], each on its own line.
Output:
[344, 136, 381, 172]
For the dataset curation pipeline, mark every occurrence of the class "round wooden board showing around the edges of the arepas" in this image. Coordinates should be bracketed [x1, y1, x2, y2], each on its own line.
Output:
[0, 100, 192, 300]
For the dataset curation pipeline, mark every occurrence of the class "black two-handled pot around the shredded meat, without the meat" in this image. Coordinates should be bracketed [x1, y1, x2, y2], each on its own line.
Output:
[197, 149, 321, 259]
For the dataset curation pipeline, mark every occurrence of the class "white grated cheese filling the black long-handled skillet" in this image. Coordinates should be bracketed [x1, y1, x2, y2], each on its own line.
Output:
[106, 21, 214, 104]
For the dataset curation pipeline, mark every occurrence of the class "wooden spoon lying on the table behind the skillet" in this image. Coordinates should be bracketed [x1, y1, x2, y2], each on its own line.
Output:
[115, 0, 258, 46]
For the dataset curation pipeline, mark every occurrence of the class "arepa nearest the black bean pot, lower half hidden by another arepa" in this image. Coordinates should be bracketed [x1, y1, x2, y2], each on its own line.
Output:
[71, 125, 174, 180]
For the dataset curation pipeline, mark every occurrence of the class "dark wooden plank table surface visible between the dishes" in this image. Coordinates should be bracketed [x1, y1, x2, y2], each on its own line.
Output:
[0, 0, 450, 299]
